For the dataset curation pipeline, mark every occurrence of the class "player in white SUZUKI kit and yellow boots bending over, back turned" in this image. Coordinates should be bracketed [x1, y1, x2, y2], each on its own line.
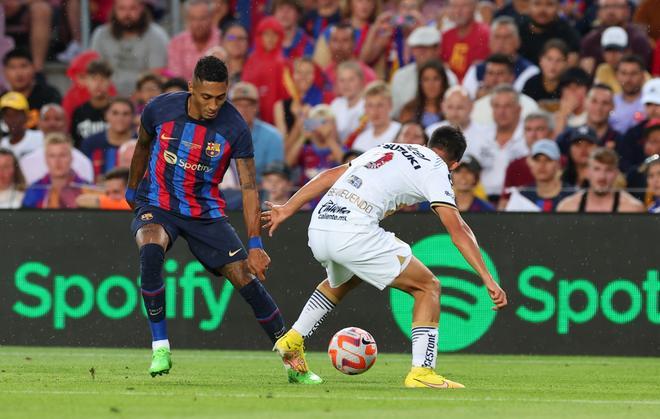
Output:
[262, 126, 507, 388]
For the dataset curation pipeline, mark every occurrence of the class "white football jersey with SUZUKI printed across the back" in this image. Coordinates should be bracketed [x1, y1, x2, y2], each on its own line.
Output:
[309, 143, 456, 232]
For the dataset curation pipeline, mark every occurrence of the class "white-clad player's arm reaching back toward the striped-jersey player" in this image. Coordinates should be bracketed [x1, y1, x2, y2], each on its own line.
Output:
[261, 164, 348, 237]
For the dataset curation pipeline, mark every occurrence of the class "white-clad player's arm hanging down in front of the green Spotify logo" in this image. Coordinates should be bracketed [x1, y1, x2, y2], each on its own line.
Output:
[433, 206, 507, 310]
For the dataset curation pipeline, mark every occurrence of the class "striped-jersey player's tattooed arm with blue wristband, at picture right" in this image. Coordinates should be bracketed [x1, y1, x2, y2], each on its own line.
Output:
[236, 158, 270, 281]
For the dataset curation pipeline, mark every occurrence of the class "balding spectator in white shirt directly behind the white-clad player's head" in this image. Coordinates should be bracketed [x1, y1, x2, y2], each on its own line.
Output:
[425, 86, 495, 154]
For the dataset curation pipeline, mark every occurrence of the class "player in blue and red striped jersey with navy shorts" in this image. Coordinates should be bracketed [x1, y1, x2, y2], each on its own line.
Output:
[126, 57, 285, 376]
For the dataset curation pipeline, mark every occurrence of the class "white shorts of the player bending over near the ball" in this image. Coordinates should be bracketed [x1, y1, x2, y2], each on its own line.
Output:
[308, 227, 412, 290]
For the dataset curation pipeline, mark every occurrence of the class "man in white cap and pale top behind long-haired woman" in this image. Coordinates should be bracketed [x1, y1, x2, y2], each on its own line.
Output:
[391, 26, 458, 117]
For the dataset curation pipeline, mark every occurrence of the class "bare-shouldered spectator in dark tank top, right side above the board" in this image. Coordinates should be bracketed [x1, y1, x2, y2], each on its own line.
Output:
[557, 148, 646, 213]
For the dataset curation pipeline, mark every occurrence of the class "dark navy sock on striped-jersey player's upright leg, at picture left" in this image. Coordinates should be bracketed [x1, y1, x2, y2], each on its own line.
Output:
[140, 243, 170, 349]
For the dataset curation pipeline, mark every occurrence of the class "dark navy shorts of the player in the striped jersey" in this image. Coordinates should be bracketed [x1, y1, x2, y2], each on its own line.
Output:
[131, 205, 247, 274]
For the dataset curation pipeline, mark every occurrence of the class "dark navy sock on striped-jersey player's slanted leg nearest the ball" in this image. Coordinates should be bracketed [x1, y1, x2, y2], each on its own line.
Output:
[238, 278, 286, 343]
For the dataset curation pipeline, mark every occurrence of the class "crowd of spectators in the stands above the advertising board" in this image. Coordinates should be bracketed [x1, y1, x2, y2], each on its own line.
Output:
[0, 0, 660, 213]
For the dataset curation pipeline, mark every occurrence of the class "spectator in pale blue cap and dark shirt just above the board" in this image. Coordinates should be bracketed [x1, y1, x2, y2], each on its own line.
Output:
[501, 139, 570, 212]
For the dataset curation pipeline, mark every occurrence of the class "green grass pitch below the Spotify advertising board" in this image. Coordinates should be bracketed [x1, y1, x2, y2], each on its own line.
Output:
[0, 347, 660, 419]
